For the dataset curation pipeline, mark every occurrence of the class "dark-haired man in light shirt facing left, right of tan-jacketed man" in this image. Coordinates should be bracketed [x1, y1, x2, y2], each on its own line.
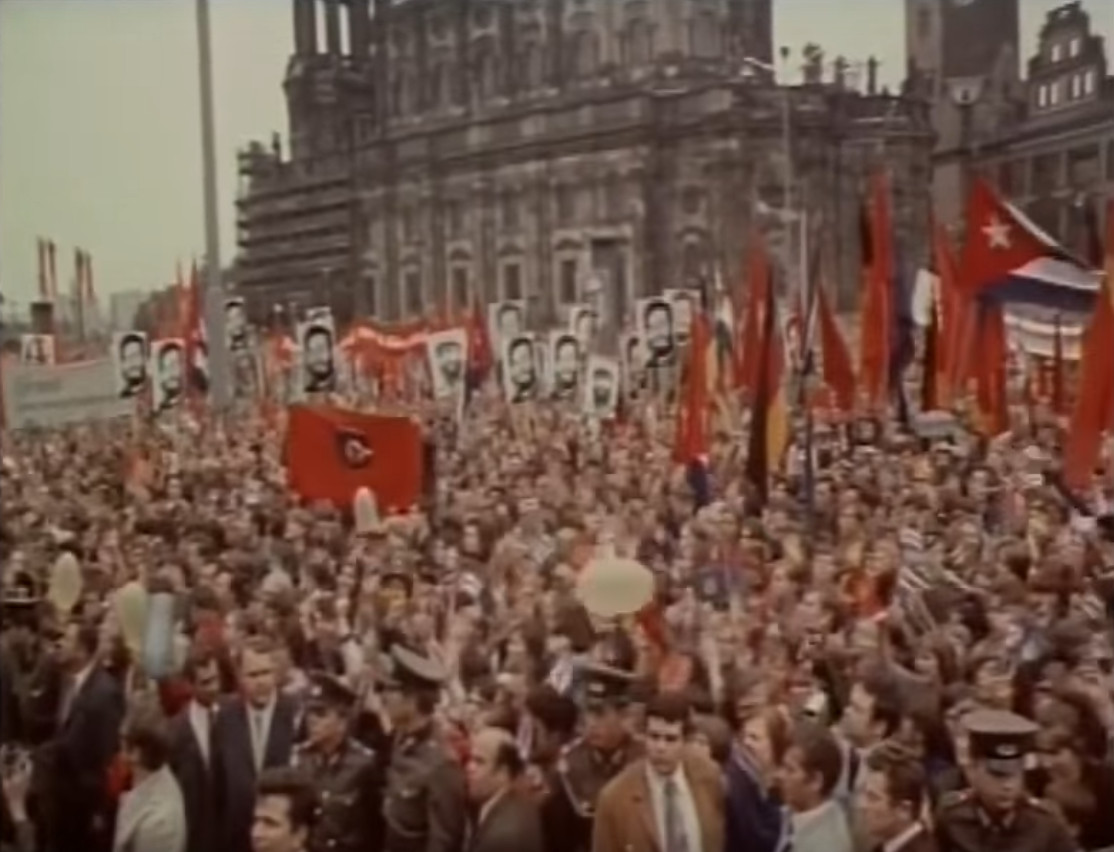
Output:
[780, 722, 854, 852]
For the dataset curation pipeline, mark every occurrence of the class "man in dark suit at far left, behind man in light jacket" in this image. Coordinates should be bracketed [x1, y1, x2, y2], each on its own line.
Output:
[43, 621, 124, 852]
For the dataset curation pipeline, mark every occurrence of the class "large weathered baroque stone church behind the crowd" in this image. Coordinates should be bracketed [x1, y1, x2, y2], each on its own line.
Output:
[236, 0, 932, 323]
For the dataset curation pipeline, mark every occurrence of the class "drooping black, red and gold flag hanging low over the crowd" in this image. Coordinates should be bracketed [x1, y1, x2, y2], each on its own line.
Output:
[746, 252, 789, 505]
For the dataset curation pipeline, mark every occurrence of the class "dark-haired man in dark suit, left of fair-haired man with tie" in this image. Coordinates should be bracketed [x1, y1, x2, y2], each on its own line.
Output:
[169, 650, 221, 852]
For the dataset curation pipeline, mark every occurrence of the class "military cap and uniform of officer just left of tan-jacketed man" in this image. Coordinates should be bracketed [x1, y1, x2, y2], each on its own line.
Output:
[541, 666, 642, 852]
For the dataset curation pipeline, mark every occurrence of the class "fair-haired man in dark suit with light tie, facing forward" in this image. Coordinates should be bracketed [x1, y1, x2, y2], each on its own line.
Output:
[213, 636, 297, 852]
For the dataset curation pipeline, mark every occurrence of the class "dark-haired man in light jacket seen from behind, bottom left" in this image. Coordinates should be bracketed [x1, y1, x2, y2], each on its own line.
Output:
[113, 708, 187, 852]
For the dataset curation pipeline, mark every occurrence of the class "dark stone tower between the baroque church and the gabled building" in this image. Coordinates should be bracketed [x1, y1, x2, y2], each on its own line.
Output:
[906, 0, 1024, 222]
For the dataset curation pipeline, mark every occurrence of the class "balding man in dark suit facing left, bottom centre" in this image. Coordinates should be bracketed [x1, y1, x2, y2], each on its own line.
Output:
[465, 728, 545, 852]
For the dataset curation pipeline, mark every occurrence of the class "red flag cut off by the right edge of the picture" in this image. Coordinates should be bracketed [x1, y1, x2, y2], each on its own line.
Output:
[1064, 200, 1114, 490]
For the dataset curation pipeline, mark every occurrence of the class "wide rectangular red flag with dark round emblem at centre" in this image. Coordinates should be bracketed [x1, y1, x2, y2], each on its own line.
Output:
[286, 405, 422, 511]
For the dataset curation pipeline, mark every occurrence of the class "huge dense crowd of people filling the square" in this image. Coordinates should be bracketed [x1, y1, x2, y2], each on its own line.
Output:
[0, 374, 1114, 852]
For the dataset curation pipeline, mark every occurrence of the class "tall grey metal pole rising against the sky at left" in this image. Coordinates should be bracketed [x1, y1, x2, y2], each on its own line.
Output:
[197, 0, 232, 411]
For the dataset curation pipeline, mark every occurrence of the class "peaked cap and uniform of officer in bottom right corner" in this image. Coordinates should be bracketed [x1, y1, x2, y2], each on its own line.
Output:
[936, 711, 1076, 852]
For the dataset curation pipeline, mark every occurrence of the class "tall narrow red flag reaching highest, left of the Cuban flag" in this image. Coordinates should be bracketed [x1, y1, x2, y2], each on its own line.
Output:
[859, 174, 893, 410]
